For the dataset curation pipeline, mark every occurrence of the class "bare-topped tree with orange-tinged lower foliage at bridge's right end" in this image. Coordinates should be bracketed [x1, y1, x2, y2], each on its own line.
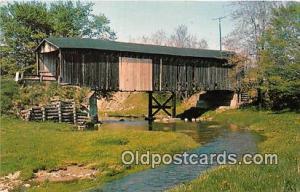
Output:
[224, 1, 280, 106]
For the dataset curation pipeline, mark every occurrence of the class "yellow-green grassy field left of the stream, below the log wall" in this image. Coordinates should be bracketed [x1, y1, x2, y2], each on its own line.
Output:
[0, 117, 197, 191]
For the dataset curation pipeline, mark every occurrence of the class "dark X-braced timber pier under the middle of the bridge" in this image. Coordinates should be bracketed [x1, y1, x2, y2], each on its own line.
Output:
[148, 91, 176, 122]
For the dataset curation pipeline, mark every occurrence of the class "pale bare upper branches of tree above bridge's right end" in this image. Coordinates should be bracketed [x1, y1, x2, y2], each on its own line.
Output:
[224, 1, 279, 58]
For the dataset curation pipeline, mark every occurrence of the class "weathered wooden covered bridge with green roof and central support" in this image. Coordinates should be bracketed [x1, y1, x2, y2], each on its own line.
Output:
[36, 37, 233, 119]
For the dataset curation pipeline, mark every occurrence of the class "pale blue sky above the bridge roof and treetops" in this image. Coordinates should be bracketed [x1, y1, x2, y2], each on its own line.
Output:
[92, 1, 233, 49]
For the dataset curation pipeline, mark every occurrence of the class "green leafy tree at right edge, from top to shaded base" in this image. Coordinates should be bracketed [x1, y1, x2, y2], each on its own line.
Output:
[259, 3, 300, 109]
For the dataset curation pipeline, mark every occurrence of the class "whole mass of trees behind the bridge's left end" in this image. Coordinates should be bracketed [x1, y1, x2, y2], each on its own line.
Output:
[0, 1, 116, 75]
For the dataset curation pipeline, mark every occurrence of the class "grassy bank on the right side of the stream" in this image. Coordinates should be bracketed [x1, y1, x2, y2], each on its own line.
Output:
[171, 110, 300, 192]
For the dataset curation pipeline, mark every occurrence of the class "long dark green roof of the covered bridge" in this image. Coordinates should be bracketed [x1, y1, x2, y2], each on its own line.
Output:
[37, 37, 234, 59]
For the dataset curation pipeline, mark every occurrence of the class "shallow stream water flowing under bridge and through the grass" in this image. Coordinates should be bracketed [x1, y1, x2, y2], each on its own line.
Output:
[91, 120, 257, 192]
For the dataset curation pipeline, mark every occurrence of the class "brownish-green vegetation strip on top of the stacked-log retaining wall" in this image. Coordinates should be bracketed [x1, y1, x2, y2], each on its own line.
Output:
[1, 79, 91, 114]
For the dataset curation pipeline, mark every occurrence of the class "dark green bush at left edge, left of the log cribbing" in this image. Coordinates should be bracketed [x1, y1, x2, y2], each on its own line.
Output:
[0, 79, 19, 114]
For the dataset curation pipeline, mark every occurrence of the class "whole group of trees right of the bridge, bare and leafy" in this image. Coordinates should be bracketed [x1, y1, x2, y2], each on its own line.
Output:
[227, 2, 300, 110]
